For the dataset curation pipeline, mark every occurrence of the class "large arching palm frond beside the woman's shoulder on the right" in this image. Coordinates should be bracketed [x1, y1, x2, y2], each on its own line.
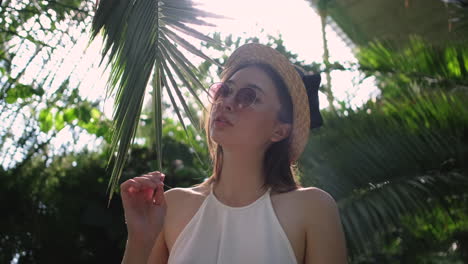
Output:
[301, 91, 468, 258]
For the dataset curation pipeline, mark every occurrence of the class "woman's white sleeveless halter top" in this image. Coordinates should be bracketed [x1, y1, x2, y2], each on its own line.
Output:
[168, 186, 297, 264]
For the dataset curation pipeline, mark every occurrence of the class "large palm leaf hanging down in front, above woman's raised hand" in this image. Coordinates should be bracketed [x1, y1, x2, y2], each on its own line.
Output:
[91, 0, 225, 201]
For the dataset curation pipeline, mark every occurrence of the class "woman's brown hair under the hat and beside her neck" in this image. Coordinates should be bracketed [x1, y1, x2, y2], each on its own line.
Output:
[202, 63, 300, 193]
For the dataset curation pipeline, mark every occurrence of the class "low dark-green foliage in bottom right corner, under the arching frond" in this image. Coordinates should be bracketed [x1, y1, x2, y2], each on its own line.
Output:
[353, 199, 468, 264]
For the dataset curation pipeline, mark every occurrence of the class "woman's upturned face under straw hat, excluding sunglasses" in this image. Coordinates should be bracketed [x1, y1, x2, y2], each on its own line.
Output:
[209, 66, 290, 154]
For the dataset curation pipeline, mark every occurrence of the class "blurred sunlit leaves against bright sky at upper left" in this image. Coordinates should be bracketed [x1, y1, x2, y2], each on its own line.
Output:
[0, 0, 109, 169]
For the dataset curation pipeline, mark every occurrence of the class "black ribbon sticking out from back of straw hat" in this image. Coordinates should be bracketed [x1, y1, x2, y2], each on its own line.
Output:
[296, 67, 323, 129]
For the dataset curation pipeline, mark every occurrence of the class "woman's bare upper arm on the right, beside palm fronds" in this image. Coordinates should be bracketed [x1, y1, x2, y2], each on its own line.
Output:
[305, 188, 347, 264]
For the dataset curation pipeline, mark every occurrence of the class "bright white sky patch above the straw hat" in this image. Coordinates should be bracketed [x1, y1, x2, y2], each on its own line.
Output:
[200, 0, 353, 62]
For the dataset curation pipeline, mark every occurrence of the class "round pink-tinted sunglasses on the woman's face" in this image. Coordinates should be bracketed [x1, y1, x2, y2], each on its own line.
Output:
[208, 82, 257, 110]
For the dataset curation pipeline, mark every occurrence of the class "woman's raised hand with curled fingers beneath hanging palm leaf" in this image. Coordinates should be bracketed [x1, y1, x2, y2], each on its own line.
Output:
[120, 171, 166, 245]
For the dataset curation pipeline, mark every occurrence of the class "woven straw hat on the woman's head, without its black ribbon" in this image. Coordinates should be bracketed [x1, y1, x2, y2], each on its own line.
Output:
[221, 43, 320, 162]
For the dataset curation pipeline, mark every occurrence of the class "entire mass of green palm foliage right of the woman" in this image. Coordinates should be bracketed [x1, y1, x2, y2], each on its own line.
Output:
[330, 37, 468, 263]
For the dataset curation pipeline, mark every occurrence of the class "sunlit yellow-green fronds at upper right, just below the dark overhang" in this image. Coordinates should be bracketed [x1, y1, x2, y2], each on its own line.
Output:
[357, 36, 468, 85]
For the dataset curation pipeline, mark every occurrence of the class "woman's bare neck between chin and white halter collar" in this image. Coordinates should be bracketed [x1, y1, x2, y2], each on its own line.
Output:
[213, 146, 265, 206]
